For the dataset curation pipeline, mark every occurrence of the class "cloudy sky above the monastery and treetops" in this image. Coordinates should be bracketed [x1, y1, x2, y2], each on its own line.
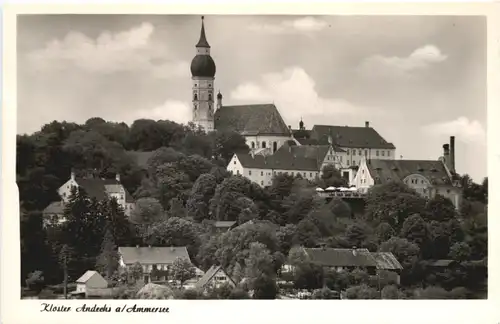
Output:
[17, 15, 487, 181]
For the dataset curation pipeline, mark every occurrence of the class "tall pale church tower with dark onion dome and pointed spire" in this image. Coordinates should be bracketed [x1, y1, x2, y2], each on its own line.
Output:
[191, 16, 215, 133]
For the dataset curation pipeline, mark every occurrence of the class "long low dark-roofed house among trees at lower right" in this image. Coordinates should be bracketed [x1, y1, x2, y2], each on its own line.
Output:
[283, 247, 402, 281]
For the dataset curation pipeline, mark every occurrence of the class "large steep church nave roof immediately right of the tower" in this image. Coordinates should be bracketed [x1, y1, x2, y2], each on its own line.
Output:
[215, 104, 290, 136]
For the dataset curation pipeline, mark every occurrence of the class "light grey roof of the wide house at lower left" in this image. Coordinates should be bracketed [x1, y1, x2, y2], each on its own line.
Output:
[118, 246, 191, 264]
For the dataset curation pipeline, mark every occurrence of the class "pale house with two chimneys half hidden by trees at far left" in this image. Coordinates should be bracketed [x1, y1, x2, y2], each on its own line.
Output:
[43, 172, 135, 225]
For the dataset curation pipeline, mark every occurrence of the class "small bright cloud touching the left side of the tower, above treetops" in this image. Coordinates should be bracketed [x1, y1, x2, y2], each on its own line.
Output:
[127, 100, 192, 124]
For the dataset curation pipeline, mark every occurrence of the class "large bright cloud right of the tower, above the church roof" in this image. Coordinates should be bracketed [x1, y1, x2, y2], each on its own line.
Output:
[231, 67, 375, 120]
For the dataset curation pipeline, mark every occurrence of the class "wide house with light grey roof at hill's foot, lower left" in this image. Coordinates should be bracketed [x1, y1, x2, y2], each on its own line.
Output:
[118, 246, 191, 283]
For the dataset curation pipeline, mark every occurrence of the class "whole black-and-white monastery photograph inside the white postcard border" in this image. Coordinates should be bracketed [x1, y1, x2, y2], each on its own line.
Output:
[7, 7, 488, 308]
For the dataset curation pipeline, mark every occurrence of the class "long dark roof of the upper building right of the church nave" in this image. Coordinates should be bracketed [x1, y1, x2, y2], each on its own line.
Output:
[311, 125, 395, 149]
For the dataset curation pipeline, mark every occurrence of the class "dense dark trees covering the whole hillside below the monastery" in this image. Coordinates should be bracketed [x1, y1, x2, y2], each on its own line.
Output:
[17, 118, 488, 299]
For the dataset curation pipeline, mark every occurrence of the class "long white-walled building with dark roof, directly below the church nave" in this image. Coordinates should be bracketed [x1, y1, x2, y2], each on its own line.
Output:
[227, 142, 354, 187]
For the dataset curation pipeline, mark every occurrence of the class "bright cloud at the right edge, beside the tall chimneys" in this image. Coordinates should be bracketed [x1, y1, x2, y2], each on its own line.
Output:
[422, 116, 486, 145]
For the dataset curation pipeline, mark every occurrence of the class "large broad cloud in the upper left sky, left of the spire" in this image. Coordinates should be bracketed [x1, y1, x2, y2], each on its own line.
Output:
[27, 23, 187, 78]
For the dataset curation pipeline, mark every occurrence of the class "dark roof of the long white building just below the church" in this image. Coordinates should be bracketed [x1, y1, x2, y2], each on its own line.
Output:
[237, 145, 344, 171]
